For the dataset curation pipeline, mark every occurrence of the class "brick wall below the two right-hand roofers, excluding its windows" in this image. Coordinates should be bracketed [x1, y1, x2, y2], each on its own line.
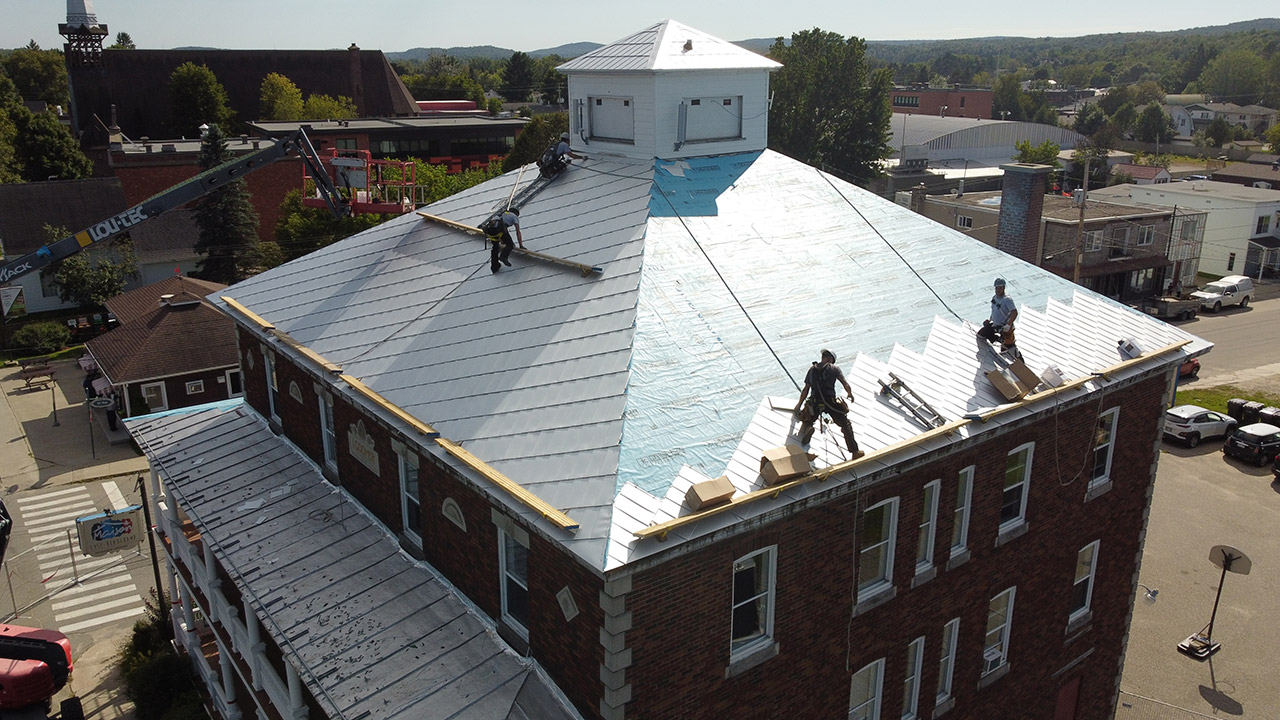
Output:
[626, 378, 1165, 720]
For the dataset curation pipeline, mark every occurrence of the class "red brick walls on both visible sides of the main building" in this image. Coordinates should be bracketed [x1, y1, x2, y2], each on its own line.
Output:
[241, 320, 1167, 720]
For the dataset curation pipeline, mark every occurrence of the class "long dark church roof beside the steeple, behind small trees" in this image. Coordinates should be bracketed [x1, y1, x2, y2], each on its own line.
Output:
[70, 50, 417, 138]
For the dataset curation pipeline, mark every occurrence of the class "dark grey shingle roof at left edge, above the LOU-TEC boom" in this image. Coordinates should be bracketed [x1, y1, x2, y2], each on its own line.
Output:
[0, 178, 125, 258]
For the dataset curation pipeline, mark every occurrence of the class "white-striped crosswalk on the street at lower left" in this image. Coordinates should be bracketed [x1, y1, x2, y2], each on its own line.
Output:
[17, 482, 146, 633]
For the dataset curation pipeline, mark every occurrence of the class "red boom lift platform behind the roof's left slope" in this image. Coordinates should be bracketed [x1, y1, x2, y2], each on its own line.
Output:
[302, 147, 417, 215]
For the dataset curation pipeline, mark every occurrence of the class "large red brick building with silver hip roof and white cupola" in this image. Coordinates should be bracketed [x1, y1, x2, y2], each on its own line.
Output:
[128, 20, 1210, 720]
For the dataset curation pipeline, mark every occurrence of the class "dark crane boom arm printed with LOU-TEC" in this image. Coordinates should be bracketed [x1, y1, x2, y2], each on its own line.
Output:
[0, 128, 348, 284]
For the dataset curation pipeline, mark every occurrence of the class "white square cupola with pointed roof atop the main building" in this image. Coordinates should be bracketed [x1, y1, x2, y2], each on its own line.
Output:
[557, 20, 782, 159]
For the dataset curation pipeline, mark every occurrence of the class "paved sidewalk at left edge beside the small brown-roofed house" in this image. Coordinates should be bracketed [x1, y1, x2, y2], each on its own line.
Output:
[0, 360, 147, 496]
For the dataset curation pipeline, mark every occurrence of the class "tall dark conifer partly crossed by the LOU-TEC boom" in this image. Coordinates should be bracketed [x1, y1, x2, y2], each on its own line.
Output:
[196, 126, 259, 284]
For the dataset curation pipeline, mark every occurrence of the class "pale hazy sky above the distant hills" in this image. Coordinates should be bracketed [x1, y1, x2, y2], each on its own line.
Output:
[0, 0, 1280, 51]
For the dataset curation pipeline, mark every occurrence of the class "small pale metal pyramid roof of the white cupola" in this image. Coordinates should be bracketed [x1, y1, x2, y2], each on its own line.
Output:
[556, 20, 782, 73]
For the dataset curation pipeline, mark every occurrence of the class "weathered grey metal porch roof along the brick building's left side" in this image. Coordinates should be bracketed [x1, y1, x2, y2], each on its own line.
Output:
[125, 404, 580, 720]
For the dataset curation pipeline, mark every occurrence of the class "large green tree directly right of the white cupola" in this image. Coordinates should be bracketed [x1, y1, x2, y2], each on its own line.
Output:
[769, 28, 892, 181]
